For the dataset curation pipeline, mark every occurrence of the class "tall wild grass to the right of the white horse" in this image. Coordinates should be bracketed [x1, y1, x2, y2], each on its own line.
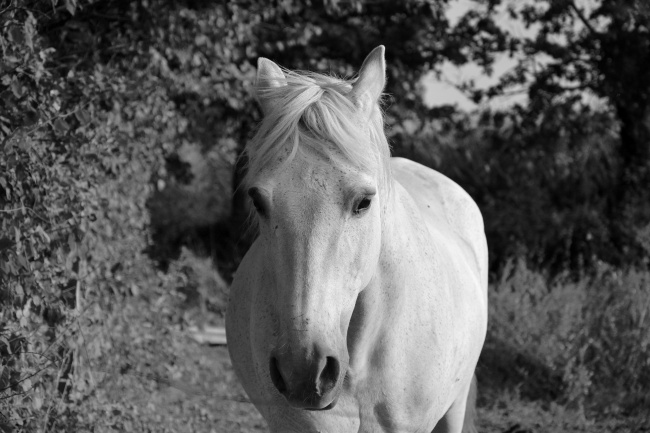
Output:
[479, 261, 650, 418]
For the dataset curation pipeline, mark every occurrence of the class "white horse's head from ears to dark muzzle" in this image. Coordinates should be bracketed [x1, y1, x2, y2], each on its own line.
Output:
[240, 47, 390, 410]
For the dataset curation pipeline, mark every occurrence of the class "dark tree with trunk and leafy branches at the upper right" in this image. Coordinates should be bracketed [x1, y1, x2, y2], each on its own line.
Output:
[459, 0, 650, 264]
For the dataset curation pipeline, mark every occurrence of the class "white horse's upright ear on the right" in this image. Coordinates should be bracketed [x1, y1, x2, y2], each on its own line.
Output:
[350, 45, 386, 111]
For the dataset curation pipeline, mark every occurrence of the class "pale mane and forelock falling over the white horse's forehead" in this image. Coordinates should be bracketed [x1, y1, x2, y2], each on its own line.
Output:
[243, 69, 390, 185]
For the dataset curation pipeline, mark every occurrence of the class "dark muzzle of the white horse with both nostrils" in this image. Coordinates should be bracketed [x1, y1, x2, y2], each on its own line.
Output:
[269, 345, 347, 410]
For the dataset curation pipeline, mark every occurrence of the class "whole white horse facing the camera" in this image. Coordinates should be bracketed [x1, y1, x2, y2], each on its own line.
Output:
[226, 46, 487, 433]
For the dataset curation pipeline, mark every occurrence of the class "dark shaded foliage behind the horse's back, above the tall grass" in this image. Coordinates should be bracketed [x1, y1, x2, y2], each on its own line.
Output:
[397, 101, 636, 274]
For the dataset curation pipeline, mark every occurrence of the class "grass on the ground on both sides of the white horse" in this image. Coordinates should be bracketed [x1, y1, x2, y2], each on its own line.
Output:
[49, 254, 650, 433]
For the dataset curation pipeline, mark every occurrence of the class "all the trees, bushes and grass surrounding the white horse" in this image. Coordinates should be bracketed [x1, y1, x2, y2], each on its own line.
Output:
[0, 0, 650, 432]
